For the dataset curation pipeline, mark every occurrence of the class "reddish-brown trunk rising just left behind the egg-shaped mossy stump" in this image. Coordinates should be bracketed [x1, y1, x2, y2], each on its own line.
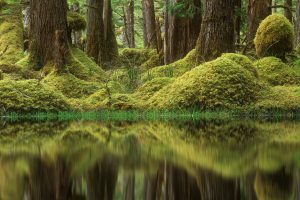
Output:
[247, 0, 272, 42]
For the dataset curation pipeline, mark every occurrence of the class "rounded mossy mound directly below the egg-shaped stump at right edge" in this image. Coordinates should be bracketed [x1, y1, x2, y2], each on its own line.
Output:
[254, 57, 300, 86]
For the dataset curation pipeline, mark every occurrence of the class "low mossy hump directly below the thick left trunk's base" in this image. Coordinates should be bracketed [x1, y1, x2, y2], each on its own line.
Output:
[42, 72, 103, 98]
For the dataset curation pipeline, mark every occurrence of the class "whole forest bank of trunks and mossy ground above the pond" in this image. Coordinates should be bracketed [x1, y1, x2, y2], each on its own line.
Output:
[0, 0, 300, 114]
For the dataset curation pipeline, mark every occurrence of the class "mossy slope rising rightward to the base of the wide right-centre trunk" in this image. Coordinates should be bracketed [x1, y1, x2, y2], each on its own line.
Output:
[142, 49, 197, 82]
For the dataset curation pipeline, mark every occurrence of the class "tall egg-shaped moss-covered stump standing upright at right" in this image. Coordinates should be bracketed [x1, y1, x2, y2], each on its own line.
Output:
[254, 14, 294, 58]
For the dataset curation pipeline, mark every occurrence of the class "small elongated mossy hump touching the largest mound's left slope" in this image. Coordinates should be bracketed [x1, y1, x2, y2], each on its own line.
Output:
[133, 77, 174, 101]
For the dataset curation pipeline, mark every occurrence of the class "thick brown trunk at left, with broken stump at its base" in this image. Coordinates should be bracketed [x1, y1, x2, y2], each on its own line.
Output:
[30, 0, 68, 69]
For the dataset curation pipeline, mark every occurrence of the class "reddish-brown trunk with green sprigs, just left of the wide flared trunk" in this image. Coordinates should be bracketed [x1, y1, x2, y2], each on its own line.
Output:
[165, 0, 202, 64]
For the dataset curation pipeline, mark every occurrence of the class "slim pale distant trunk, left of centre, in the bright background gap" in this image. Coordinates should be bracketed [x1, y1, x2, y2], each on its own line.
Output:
[124, 0, 135, 48]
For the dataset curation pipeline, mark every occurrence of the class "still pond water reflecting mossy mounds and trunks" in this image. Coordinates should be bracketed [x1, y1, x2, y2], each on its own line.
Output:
[0, 120, 300, 200]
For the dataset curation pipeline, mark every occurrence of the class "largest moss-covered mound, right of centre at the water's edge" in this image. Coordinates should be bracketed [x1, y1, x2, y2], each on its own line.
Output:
[147, 58, 260, 109]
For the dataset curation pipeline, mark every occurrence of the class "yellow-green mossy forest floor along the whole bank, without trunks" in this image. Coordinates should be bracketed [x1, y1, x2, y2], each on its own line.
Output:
[0, 2, 300, 115]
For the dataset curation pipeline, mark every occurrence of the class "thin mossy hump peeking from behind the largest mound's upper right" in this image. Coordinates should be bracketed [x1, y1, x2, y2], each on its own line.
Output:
[221, 53, 258, 77]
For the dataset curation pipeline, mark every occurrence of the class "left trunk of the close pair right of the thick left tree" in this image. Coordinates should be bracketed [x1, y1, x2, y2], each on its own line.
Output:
[86, 0, 104, 62]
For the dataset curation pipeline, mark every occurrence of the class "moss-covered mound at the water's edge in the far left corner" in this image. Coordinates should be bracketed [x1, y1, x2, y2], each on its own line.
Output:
[0, 80, 71, 112]
